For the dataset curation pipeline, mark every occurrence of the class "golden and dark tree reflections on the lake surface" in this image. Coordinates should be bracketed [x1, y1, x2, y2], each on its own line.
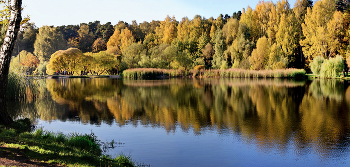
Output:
[8, 78, 350, 156]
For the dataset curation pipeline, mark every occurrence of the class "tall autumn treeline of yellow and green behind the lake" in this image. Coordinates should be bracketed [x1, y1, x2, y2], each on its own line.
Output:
[8, 0, 350, 73]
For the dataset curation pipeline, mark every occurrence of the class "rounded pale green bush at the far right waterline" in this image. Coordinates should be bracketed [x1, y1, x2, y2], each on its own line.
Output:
[320, 55, 344, 78]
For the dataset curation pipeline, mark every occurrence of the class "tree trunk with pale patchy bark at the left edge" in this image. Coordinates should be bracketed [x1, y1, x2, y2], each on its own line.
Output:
[0, 0, 22, 125]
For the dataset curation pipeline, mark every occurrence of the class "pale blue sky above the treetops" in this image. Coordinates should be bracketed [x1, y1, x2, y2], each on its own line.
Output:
[23, 0, 296, 27]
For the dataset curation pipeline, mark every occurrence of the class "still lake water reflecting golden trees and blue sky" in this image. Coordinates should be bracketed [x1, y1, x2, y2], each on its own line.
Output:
[9, 78, 350, 166]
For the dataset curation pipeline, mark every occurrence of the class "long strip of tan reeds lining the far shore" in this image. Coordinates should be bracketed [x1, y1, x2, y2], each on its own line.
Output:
[123, 68, 306, 79]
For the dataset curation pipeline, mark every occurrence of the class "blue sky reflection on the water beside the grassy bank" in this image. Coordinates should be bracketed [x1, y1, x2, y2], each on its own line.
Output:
[38, 121, 350, 166]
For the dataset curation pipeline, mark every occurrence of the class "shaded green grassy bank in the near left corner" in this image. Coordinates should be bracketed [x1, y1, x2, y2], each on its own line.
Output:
[0, 119, 135, 166]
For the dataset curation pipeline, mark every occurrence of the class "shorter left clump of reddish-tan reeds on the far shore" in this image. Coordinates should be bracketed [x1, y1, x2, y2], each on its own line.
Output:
[123, 68, 184, 79]
